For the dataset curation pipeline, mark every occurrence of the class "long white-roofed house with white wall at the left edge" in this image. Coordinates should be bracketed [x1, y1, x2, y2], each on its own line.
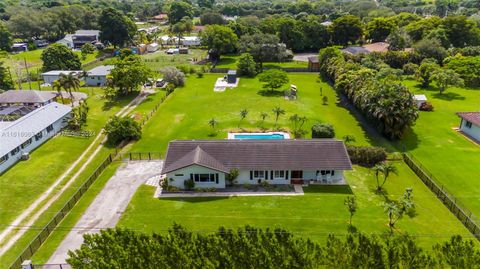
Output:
[0, 102, 72, 174]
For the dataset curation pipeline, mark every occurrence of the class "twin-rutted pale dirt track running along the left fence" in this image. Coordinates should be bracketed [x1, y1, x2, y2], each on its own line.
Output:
[0, 90, 151, 256]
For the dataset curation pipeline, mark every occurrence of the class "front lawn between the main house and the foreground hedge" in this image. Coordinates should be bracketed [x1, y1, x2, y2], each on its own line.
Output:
[118, 162, 471, 246]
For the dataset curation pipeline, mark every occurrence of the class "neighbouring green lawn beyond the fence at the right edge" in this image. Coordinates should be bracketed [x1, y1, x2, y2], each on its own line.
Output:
[398, 78, 480, 217]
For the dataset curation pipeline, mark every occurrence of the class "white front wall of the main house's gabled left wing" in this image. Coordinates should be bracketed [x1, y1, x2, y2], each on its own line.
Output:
[167, 165, 225, 189]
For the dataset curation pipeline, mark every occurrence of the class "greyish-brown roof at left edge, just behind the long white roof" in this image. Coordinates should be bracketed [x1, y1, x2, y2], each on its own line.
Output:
[0, 90, 58, 104]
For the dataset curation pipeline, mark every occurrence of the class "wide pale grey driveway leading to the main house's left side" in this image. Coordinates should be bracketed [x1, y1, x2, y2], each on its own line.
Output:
[48, 161, 163, 264]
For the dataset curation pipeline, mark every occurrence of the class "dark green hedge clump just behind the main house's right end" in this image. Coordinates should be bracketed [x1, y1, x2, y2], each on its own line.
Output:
[347, 145, 387, 167]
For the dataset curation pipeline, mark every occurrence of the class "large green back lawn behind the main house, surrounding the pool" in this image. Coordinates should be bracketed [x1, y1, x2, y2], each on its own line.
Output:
[133, 74, 388, 152]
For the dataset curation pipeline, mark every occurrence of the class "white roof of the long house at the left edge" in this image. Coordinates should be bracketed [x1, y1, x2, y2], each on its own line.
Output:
[0, 102, 72, 156]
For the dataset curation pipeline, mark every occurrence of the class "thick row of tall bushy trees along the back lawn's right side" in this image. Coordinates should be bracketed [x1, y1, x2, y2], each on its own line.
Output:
[319, 47, 418, 139]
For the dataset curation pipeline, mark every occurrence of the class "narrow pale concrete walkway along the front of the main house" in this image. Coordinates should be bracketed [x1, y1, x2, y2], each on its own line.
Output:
[159, 185, 305, 198]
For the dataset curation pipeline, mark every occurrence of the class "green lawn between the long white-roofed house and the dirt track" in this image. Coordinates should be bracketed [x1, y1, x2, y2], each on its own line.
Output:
[0, 88, 132, 230]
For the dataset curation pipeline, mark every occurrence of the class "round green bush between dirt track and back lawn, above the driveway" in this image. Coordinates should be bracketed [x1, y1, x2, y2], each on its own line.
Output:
[105, 116, 142, 145]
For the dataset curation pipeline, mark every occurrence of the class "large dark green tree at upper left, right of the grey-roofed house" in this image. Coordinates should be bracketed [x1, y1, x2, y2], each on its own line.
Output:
[98, 8, 137, 47]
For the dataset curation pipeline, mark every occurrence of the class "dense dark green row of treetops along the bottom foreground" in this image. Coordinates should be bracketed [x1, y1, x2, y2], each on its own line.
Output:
[67, 225, 480, 269]
